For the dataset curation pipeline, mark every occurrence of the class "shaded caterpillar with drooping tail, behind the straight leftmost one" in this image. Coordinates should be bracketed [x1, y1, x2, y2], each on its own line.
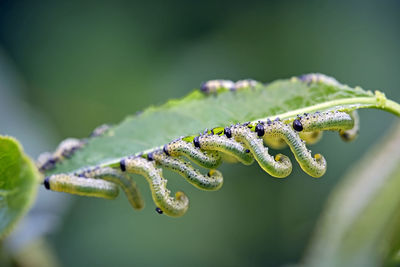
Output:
[80, 167, 144, 210]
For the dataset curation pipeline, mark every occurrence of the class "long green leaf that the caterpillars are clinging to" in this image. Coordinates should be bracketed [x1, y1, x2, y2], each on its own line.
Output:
[47, 75, 400, 174]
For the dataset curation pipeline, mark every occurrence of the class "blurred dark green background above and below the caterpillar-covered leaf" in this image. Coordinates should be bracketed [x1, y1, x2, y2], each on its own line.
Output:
[0, 1, 400, 266]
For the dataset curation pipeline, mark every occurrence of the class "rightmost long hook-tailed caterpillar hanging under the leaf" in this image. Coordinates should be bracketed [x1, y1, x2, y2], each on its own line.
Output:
[255, 121, 326, 177]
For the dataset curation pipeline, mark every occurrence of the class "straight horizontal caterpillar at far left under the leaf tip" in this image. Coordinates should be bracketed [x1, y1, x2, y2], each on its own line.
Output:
[44, 174, 119, 199]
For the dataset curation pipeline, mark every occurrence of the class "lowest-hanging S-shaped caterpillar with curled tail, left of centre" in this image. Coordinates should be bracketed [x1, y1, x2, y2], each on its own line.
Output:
[120, 157, 189, 217]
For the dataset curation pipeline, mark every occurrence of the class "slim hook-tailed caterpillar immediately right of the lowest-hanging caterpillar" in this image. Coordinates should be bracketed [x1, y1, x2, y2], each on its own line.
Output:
[147, 151, 223, 190]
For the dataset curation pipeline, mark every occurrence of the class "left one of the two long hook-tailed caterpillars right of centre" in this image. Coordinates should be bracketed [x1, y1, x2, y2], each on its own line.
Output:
[230, 125, 292, 178]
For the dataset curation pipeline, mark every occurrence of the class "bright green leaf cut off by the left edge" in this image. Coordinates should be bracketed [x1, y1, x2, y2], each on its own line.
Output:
[0, 136, 40, 239]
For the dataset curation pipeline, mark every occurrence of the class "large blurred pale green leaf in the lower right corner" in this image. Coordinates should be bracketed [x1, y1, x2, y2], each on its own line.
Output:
[305, 123, 400, 266]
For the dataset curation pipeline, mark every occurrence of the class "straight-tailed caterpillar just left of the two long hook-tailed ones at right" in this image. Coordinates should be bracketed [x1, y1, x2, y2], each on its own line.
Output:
[193, 133, 254, 165]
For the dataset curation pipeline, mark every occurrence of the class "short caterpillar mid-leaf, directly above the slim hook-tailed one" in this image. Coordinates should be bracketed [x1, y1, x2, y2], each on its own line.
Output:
[163, 139, 222, 169]
